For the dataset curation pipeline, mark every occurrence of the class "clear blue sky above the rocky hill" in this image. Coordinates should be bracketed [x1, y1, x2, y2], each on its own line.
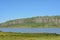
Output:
[0, 0, 60, 23]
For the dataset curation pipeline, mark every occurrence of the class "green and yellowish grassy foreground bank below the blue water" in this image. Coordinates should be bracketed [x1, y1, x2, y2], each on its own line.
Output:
[0, 32, 60, 40]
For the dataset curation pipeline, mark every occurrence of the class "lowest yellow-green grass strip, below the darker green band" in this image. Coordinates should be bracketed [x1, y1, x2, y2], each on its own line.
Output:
[0, 36, 60, 40]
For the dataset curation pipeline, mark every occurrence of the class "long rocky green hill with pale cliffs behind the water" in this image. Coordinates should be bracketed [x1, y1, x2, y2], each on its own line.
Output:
[0, 16, 60, 28]
